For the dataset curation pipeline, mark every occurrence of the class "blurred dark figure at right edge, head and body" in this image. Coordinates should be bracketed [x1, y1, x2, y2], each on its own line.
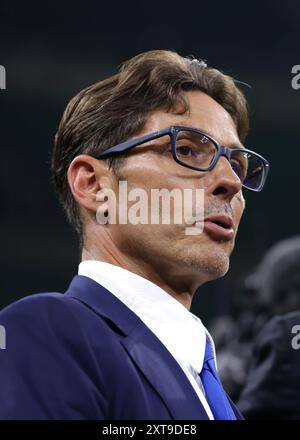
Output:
[239, 236, 300, 420]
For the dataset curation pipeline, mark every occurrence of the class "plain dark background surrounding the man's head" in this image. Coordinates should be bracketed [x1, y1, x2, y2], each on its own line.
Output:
[0, 0, 300, 321]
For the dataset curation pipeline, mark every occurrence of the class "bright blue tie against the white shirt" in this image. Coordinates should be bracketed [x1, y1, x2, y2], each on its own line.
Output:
[200, 340, 236, 420]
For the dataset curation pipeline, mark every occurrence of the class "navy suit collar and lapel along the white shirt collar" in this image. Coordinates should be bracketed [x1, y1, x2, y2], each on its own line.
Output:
[65, 276, 208, 420]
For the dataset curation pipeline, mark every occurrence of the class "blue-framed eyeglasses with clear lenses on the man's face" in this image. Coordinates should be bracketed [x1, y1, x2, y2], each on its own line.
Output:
[97, 125, 270, 192]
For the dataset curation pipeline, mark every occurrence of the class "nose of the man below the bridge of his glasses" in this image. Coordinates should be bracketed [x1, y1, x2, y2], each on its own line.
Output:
[207, 156, 242, 202]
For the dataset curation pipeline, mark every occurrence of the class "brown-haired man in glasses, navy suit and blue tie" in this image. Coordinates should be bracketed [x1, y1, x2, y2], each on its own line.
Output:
[0, 50, 268, 419]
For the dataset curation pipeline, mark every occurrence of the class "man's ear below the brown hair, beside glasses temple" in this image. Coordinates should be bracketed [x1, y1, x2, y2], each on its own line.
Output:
[67, 154, 113, 214]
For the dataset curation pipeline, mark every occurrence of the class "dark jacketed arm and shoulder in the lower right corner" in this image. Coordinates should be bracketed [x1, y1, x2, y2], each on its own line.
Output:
[239, 310, 300, 420]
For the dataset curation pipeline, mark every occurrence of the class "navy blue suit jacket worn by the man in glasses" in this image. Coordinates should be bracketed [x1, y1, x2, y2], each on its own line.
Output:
[0, 276, 241, 420]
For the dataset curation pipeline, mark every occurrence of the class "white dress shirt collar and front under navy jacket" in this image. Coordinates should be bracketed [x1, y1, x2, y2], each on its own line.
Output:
[78, 260, 214, 419]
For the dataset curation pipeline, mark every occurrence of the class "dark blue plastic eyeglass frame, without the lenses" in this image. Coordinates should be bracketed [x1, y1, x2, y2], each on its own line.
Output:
[97, 125, 270, 192]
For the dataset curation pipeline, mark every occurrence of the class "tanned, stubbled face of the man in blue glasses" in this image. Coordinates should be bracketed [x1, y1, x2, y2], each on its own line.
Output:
[106, 91, 244, 289]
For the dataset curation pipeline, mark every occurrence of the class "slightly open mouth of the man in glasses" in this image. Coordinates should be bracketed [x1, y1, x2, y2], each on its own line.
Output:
[204, 214, 234, 241]
